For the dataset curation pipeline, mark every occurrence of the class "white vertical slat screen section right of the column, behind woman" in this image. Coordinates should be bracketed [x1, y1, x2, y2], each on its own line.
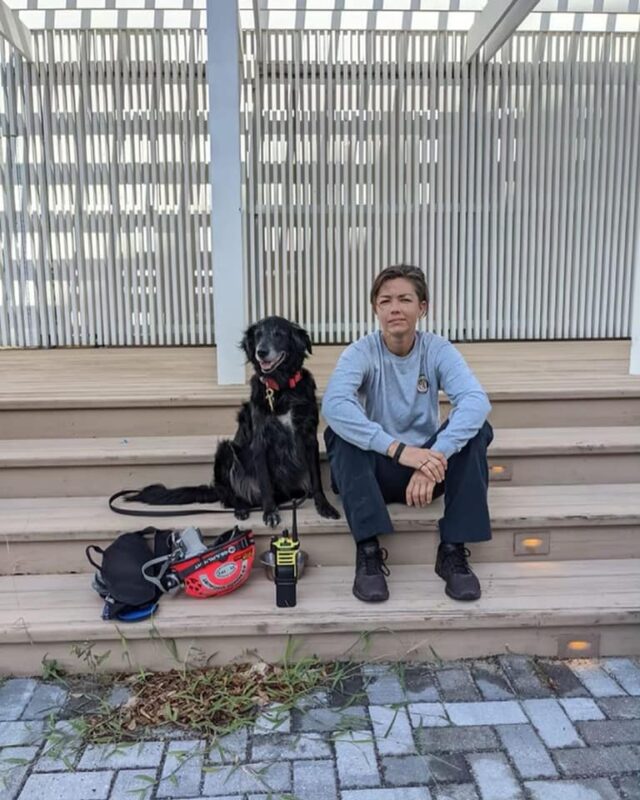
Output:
[245, 31, 640, 342]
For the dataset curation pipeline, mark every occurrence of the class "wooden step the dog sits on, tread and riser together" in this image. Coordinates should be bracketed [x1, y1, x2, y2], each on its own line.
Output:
[0, 484, 640, 574]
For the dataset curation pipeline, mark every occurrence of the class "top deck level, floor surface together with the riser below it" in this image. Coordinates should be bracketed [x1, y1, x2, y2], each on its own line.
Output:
[0, 341, 640, 439]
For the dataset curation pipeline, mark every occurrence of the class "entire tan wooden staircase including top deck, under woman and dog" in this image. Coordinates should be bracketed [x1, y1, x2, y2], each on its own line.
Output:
[0, 341, 640, 674]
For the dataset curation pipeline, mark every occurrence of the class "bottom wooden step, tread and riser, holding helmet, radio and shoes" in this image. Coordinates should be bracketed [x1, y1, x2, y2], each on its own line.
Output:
[0, 558, 640, 675]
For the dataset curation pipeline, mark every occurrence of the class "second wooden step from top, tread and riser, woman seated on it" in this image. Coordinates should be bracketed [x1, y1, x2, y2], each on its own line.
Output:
[0, 426, 640, 497]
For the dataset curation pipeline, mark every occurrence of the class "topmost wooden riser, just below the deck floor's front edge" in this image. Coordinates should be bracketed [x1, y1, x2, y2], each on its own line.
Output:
[0, 397, 640, 439]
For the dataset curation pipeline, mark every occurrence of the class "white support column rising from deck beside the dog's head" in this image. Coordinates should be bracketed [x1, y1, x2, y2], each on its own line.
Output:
[207, 0, 246, 384]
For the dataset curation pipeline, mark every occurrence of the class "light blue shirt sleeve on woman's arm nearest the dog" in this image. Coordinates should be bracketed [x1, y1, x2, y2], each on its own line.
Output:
[322, 345, 394, 455]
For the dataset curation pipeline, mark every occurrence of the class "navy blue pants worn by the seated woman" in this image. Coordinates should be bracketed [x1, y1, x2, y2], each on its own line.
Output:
[324, 422, 493, 543]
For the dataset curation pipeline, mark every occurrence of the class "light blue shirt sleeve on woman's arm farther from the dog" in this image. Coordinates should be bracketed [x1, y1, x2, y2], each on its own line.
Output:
[432, 342, 491, 458]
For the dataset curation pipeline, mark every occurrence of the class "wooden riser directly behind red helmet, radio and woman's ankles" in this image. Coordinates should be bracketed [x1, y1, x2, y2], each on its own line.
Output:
[6, 517, 640, 582]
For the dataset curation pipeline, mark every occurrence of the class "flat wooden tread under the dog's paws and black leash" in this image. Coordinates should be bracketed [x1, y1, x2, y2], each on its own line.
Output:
[0, 484, 640, 542]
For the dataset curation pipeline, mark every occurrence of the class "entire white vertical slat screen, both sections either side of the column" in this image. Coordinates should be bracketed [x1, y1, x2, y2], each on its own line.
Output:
[0, 30, 640, 347]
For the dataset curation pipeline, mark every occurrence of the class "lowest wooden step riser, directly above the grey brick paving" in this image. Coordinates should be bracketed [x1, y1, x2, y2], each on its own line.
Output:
[0, 620, 640, 675]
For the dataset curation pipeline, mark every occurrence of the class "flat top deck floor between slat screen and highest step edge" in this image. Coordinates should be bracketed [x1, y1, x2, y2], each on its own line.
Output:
[0, 340, 640, 410]
